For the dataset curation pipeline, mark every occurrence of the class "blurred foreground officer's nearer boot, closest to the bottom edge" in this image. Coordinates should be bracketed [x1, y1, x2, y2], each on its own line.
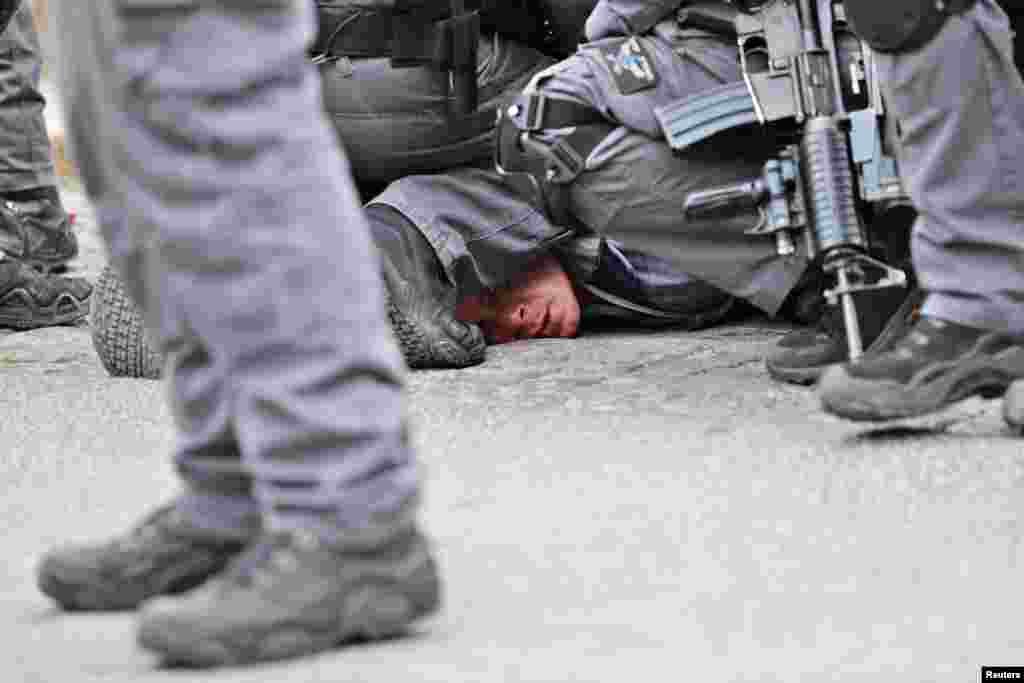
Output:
[138, 528, 440, 667]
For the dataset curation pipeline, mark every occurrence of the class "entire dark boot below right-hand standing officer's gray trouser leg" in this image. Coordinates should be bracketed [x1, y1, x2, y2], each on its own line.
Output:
[818, 315, 1024, 421]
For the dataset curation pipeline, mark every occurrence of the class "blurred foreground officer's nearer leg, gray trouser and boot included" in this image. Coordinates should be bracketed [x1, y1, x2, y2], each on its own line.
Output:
[38, 0, 437, 664]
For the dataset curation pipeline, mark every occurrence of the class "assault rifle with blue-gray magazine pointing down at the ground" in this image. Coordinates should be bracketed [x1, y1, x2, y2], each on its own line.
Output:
[655, 0, 908, 359]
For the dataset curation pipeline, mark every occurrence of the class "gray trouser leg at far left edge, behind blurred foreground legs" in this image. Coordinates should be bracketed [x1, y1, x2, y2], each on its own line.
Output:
[0, 0, 56, 193]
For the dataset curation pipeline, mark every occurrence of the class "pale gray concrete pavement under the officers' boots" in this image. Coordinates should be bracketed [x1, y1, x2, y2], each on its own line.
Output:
[6, 187, 1024, 683]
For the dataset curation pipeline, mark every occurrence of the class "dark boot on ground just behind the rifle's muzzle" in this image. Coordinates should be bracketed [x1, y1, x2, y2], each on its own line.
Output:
[765, 287, 921, 385]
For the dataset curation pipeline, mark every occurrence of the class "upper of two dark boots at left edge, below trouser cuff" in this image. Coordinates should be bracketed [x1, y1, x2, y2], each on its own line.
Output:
[0, 187, 78, 271]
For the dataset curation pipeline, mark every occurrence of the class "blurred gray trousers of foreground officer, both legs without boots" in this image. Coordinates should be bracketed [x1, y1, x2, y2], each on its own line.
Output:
[49, 0, 418, 537]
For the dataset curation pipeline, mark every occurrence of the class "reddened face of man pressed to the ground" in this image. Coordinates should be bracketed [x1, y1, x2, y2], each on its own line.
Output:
[456, 256, 580, 344]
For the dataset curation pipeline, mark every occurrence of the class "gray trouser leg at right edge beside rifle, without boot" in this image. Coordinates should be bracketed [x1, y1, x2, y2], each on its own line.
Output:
[879, 0, 1024, 334]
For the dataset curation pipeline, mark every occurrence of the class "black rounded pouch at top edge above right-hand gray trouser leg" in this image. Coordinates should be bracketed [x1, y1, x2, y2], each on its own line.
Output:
[845, 0, 977, 52]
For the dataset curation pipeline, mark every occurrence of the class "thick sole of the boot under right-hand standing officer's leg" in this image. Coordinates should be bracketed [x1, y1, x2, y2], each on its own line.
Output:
[818, 347, 1024, 422]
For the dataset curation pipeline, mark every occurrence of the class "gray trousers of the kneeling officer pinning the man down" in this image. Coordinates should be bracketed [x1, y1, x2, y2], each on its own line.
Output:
[374, 22, 806, 313]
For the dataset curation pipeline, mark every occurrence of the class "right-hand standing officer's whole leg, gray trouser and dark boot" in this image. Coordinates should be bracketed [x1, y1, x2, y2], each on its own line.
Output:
[821, 0, 1024, 419]
